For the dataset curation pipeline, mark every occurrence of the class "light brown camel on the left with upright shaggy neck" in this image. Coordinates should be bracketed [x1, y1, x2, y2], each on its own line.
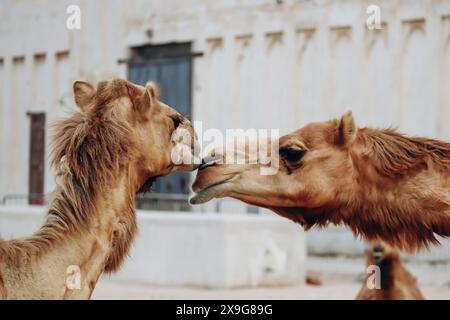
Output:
[0, 79, 196, 299]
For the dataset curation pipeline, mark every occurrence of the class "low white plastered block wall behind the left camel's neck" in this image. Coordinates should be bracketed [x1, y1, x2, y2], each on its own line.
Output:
[0, 206, 306, 288]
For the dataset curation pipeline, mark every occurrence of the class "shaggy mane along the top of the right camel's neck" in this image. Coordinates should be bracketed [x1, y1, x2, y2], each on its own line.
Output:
[358, 128, 450, 178]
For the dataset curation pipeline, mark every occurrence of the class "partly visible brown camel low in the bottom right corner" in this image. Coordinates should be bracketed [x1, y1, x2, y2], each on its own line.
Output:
[356, 243, 424, 300]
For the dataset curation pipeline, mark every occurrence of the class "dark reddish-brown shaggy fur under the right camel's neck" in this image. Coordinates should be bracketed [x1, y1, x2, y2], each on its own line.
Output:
[340, 183, 450, 252]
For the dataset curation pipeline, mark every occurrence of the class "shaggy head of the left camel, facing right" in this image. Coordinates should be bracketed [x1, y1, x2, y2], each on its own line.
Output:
[53, 79, 198, 189]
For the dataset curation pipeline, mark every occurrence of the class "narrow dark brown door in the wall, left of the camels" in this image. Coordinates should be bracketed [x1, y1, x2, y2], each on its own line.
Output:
[28, 113, 45, 204]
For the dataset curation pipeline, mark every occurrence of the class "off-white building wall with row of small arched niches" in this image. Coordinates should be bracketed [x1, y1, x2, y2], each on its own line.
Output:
[0, 0, 450, 198]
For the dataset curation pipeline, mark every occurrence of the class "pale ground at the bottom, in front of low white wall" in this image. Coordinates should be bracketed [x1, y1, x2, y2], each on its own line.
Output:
[93, 257, 450, 300]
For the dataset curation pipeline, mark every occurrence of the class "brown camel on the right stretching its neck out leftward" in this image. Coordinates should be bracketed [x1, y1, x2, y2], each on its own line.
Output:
[191, 112, 450, 251]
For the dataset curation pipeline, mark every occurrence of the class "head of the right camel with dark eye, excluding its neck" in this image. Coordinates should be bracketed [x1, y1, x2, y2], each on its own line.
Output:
[191, 113, 356, 219]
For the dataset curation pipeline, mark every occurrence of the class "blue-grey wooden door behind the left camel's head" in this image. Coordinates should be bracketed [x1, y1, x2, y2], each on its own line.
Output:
[128, 44, 192, 194]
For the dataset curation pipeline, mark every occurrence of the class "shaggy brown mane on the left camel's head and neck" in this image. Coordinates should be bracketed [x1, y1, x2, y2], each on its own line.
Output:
[0, 79, 136, 271]
